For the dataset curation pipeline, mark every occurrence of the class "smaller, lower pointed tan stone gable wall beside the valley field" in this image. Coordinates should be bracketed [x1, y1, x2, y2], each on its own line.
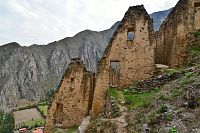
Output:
[45, 59, 94, 133]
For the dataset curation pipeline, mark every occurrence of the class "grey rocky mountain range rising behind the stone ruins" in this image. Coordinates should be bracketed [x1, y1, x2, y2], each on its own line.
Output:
[0, 9, 171, 111]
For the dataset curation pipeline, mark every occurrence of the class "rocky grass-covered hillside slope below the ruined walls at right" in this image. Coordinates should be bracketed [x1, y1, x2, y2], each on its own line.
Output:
[89, 65, 200, 133]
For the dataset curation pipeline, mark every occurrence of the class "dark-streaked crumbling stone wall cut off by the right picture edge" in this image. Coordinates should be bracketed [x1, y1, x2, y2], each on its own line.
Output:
[155, 0, 200, 67]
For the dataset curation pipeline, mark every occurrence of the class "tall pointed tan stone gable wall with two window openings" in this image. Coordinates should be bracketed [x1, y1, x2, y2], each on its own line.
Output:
[92, 5, 155, 116]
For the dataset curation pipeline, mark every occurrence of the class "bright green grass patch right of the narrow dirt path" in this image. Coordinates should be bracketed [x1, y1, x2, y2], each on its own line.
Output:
[124, 89, 160, 109]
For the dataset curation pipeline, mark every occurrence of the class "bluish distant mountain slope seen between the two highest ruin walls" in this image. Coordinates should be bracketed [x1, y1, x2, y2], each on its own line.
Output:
[150, 8, 173, 31]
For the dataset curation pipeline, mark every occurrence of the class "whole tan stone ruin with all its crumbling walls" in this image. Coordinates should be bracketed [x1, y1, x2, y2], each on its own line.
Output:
[45, 0, 200, 133]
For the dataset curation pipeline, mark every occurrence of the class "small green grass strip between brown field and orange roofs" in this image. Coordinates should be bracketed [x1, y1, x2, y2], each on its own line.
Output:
[25, 119, 45, 129]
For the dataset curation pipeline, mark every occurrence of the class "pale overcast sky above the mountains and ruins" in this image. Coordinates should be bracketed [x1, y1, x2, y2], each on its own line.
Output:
[0, 0, 178, 46]
